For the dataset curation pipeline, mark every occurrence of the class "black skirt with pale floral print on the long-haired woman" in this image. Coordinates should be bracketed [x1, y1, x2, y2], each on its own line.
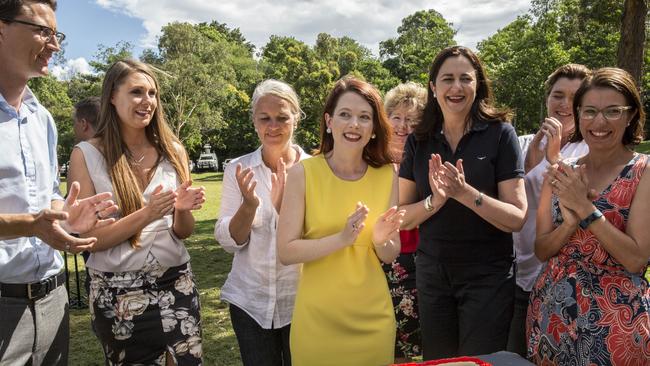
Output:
[89, 253, 203, 366]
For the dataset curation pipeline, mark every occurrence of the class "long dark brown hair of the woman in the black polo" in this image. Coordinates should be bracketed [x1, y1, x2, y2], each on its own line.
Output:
[414, 46, 511, 140]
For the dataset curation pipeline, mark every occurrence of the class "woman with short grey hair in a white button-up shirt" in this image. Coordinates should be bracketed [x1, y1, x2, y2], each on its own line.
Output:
[214, 79, 309, 366]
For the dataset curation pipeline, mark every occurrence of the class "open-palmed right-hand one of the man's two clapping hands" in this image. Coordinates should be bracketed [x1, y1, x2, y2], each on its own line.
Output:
[61, 182, 117, 234]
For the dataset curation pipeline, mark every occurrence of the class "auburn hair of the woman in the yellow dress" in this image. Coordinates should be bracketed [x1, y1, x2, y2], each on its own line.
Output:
[315, 76, 393, 168]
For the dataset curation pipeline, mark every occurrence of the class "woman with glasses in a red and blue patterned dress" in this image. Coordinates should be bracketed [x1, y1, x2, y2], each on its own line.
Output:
[527, 68, 650, 365]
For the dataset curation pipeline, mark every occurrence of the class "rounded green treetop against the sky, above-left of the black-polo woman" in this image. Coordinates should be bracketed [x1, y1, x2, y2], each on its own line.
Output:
[379, 9, 456, 84]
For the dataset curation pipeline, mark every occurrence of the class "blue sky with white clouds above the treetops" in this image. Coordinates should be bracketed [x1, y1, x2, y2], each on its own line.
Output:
[52, 0, 530, 78]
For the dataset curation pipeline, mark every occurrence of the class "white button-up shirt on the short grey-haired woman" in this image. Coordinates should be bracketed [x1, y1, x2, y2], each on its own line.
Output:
[214, 145, 309, 329]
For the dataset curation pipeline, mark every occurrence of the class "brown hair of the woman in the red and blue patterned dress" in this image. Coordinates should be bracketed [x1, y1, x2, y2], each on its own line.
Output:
[570, 67, 645, 147]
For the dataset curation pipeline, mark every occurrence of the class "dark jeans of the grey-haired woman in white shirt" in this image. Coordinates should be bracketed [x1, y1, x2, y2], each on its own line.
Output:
[230, 304, 291, 366]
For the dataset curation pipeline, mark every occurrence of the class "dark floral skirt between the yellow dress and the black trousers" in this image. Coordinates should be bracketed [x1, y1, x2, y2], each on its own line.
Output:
[383, 253, 422, 359]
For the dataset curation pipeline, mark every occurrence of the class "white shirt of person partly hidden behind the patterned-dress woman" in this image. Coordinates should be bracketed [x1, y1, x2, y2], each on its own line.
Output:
[512, 137, 589, 292]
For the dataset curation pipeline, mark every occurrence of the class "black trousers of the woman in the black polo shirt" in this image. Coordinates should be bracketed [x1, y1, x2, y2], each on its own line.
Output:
[416, 251, 515, 360]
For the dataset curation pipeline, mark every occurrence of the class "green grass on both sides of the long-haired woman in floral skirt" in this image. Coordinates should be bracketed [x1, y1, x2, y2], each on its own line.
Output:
[63, 173, 241, 366]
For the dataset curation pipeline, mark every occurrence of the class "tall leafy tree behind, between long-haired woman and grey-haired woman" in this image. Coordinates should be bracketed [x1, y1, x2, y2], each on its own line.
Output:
[143, 22, 261, 159]
